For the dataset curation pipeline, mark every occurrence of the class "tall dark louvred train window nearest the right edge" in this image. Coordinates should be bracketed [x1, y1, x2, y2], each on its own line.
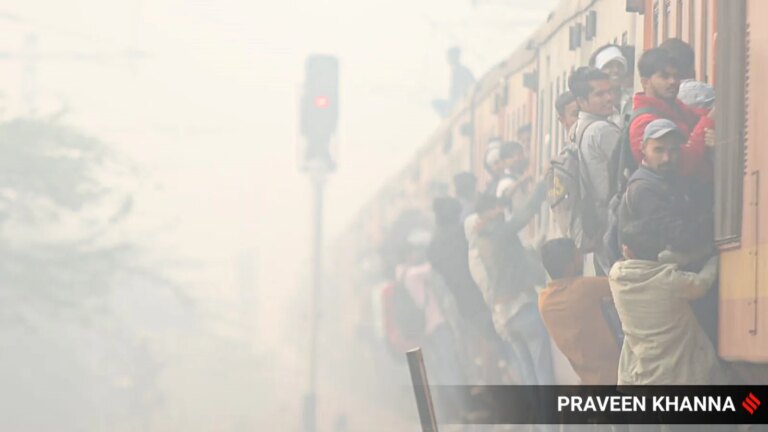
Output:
[714, 0, 749, 244]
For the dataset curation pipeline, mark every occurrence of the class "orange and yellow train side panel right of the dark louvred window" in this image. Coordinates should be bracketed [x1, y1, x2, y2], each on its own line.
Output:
[718, 0, 768, 362]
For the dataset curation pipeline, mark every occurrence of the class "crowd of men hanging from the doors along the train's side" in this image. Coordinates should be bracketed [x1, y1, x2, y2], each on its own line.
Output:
[376, 39, 736, 404]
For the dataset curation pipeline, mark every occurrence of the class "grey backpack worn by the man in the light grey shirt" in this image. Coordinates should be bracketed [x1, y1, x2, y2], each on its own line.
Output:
[546, 121, 602, 252]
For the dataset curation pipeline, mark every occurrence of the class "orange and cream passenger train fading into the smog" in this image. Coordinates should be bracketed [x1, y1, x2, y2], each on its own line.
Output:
[330, 0, 768, 383]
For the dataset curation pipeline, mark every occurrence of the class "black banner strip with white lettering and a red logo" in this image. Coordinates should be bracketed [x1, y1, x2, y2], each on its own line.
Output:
[430, 386, 768, 424]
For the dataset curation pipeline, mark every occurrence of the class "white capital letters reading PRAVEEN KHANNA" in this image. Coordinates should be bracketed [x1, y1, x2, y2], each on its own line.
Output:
[557, 396, 736, 412]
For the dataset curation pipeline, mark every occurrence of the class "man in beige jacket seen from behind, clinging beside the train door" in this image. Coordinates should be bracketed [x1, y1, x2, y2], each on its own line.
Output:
[609, 218, 731, 388]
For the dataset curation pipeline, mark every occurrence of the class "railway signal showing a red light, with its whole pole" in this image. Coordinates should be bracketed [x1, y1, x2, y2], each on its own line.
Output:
[301, 55, 339, 432]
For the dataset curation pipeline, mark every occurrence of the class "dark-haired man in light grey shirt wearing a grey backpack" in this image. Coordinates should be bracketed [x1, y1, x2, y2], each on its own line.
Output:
[568, 67, 621, 272]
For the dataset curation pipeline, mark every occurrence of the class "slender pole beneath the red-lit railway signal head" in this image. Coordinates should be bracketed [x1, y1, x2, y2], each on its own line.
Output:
[304, 164, 325, 432]
